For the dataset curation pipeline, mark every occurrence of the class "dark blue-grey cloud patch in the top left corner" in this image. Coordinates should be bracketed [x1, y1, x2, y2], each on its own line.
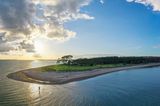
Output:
[0, 0, 34, 35]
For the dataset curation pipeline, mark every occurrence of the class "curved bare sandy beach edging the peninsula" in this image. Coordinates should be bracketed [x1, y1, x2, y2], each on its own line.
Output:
[7, 63, 160, 84]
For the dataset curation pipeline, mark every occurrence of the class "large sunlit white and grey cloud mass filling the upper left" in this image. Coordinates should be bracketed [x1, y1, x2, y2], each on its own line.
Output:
[0, 0, 96, 53]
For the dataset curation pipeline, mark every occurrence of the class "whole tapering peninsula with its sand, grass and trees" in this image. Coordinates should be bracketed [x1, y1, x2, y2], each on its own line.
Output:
[7, 55, 160, 84]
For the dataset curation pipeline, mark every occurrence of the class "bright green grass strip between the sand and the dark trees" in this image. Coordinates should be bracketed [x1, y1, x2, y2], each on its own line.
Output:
[43, 64, 128, 72]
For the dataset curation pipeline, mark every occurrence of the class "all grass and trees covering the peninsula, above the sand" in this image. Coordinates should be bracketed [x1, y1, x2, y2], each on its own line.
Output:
[43, 55, 160, 72]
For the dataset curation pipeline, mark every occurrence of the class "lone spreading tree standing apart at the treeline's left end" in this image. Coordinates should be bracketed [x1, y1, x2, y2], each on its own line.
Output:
[57, 55, 73, 65]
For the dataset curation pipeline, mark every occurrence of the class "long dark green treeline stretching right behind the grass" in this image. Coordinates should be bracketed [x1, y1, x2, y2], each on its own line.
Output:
[72, 56, 160, 66]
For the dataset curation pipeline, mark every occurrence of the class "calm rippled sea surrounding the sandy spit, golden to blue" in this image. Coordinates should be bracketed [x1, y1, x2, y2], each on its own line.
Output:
[0, 61, 160, 106]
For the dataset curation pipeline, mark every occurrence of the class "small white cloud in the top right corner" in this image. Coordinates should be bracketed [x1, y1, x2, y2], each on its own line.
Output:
[127, 0, 160, 11]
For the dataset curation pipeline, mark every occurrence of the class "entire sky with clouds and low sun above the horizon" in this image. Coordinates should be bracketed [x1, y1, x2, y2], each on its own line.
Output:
[0, 0, 160, 60]
